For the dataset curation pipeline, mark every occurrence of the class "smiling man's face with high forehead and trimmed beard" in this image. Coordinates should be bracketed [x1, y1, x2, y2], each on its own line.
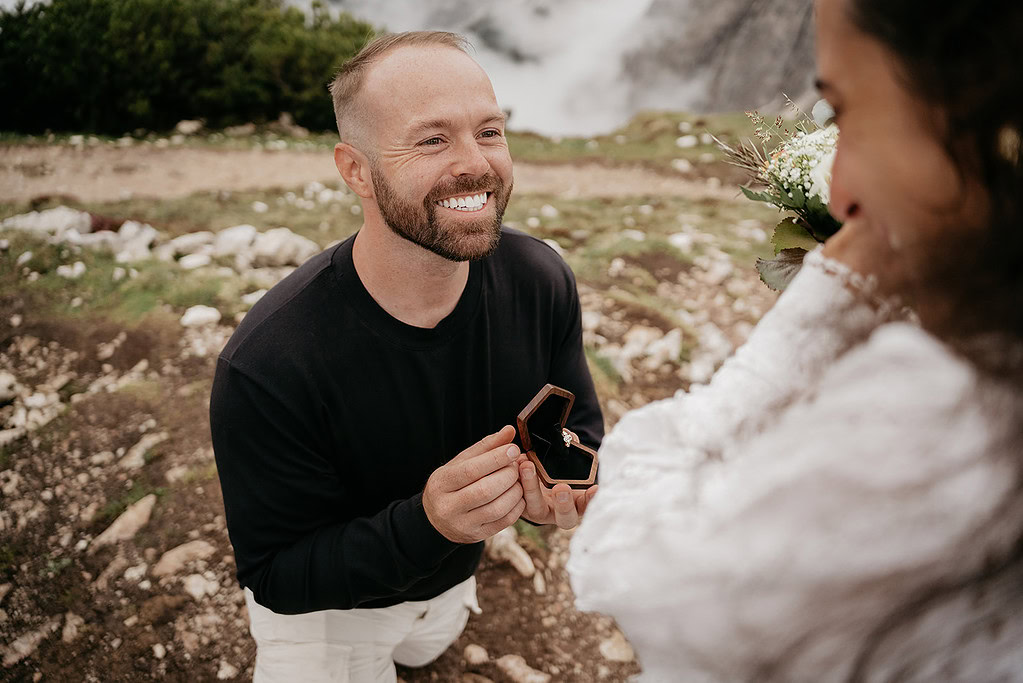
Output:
[359, 46, 513, 261]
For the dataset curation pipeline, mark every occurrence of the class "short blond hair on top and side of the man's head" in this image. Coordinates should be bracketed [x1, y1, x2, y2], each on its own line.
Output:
[327, 31, 472, 143]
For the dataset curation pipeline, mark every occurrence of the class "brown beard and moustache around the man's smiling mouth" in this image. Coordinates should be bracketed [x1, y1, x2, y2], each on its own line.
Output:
[370, 165, 512, 262]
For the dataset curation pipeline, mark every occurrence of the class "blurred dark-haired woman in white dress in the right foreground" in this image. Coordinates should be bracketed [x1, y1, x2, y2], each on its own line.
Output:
[569, 0, 1023, 682]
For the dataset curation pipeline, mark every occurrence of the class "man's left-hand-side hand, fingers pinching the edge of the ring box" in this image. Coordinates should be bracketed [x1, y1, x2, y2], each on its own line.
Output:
[422, 426, 526, 543]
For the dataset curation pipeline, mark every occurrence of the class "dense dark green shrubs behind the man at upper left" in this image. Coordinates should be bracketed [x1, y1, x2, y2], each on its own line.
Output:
[0, 0, 372, 135]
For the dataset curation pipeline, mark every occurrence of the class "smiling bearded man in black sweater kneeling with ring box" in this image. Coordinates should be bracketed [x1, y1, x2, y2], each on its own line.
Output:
[211, 32, 604, 682]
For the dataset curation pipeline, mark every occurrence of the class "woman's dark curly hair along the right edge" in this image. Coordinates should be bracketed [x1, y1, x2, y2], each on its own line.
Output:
[846, 0, 1023, 681]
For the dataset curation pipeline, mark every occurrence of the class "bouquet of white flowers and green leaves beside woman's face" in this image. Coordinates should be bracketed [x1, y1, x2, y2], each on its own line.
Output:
[715, 100, 842, 290]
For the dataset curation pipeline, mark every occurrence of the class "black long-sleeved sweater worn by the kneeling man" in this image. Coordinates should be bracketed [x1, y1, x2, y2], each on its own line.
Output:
[210, 229, 604, 613]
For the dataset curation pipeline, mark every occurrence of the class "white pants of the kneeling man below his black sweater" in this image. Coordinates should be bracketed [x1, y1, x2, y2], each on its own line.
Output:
[246, 577, 480, 683]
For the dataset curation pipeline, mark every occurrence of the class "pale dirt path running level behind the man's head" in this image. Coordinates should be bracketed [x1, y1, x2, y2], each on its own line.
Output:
[0, 146, 738, 201]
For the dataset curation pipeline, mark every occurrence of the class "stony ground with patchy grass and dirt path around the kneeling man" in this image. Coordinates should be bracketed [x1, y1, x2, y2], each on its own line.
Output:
[0, 125, 773, 683]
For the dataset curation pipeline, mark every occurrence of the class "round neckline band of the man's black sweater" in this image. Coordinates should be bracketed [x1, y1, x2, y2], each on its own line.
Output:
[330, 233, 483, 347]
